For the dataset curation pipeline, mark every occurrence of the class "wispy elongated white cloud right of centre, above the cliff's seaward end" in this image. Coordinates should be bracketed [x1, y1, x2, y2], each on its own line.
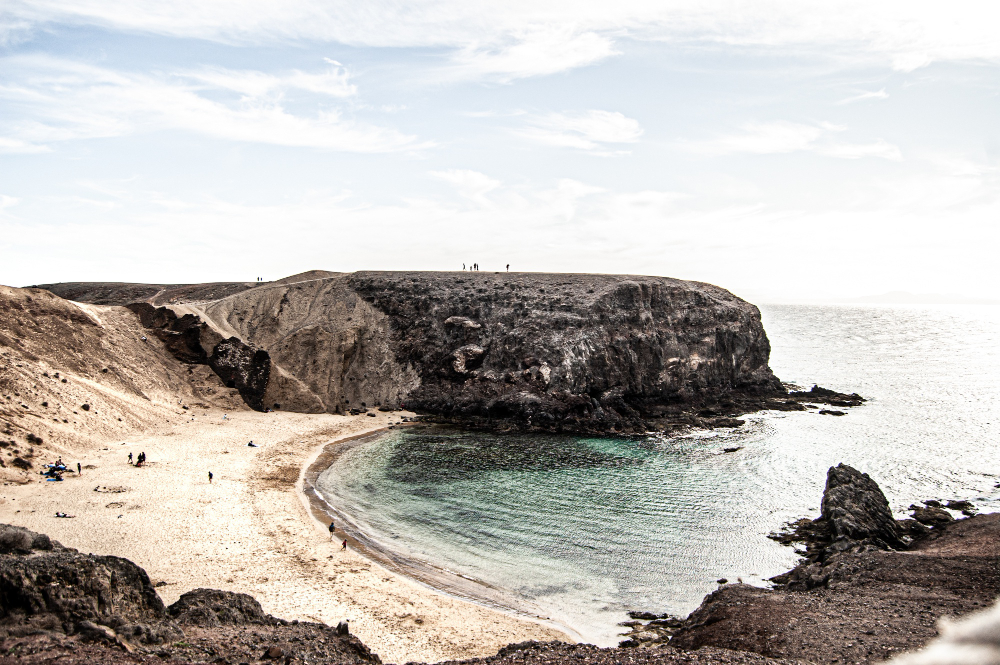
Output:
[685, 120, 902, 161]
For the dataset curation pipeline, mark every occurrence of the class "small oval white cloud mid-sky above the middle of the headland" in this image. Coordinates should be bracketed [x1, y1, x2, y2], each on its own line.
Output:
[515, 110, 642, 150]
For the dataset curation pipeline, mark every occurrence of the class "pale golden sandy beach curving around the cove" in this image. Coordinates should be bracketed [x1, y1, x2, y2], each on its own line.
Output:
[0, 408, 567, 663]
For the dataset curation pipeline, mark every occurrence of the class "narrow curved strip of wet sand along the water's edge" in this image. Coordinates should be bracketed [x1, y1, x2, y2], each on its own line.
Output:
[295, 427, 581, 642]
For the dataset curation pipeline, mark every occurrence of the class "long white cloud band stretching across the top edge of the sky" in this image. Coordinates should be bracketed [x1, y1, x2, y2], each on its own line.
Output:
[0, 0, 1000, 80]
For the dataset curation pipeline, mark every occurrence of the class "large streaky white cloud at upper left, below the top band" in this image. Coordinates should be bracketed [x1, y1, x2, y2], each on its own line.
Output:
[0, 58, 429, 152]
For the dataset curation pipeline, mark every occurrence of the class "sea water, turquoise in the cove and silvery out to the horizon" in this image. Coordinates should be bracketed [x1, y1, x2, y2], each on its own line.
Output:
[317, 306, 1000, 645]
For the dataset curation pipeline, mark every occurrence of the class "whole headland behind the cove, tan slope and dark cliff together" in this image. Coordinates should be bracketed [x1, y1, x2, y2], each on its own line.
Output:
[37, 271, 863, 434]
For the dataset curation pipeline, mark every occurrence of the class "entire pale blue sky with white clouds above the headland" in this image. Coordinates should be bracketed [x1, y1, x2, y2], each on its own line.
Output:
[0, 0, 1000, 302]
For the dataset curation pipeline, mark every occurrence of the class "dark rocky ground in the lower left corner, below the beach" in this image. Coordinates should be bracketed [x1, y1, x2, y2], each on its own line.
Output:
[0, 525, 381, 664]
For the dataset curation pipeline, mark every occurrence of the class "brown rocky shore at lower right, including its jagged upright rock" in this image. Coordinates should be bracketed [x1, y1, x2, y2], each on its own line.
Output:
[670, 464, 1000, 664]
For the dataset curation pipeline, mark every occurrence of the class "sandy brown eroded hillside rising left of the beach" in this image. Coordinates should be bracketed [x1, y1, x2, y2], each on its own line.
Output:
[0, 286, 246, 480]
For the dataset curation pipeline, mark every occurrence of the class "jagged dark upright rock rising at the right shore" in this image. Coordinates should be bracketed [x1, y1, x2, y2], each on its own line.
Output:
[821, 464, 903, 551]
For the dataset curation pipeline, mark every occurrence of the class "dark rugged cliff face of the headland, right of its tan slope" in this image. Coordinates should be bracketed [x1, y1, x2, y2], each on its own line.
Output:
[348, 273, 781, 431]
